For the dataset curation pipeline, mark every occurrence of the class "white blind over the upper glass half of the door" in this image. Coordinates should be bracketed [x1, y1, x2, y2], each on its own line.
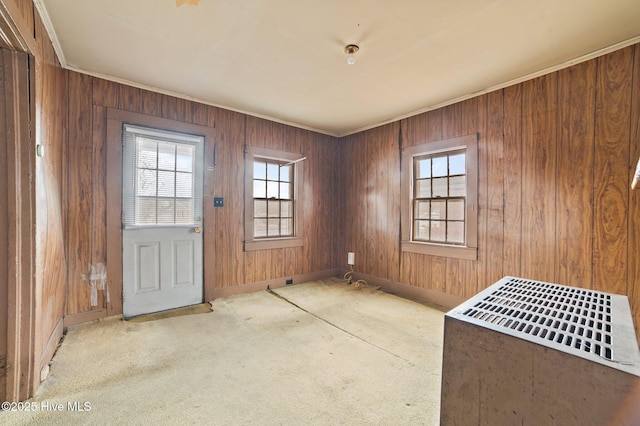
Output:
[122, 124, 204, 229]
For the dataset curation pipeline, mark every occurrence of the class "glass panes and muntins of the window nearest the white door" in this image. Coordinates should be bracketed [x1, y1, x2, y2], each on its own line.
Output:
[253, 158, 295, 239]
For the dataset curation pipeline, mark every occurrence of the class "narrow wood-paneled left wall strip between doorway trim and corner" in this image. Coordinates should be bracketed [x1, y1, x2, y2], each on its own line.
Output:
[31, 8, 67, 380]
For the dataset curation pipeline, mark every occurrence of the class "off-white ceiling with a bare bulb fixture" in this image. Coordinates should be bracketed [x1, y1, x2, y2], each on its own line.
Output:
[35, 0, 640, 136]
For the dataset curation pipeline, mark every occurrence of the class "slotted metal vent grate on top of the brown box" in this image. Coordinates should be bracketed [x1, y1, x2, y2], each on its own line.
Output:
[463, 277, 614, 360]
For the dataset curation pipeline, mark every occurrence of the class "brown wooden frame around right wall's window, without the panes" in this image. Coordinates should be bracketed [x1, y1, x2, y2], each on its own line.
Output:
[400, 133, 478, 260]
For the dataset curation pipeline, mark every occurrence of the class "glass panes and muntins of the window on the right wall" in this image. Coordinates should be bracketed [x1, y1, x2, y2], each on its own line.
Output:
[412, 149, 466, 245]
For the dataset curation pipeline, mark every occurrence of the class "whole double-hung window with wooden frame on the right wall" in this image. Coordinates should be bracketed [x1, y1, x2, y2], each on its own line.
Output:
[401, 135, 477, 260]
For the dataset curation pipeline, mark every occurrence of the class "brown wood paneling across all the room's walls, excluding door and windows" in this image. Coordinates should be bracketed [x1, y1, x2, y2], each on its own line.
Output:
[0, 0, 640, 402]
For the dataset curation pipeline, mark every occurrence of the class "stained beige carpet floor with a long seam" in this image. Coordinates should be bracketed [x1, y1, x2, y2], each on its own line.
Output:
[0, 279, 443, 425]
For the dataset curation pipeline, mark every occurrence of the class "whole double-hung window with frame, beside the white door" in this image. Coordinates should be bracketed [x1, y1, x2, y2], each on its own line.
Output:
[245, 147, 303, 250]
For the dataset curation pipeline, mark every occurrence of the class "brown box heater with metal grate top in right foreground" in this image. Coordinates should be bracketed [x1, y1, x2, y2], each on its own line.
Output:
[440, 277, 640, 425]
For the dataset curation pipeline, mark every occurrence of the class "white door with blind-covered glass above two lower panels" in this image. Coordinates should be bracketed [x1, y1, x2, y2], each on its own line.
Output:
[122, 125, 204, 318]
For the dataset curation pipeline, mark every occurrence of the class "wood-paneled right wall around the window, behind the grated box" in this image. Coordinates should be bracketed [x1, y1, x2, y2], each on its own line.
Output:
[337, 45, 640, 336]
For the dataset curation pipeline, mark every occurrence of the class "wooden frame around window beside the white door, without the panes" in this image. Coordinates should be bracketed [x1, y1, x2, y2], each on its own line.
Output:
[244, 146, 304, 251]
